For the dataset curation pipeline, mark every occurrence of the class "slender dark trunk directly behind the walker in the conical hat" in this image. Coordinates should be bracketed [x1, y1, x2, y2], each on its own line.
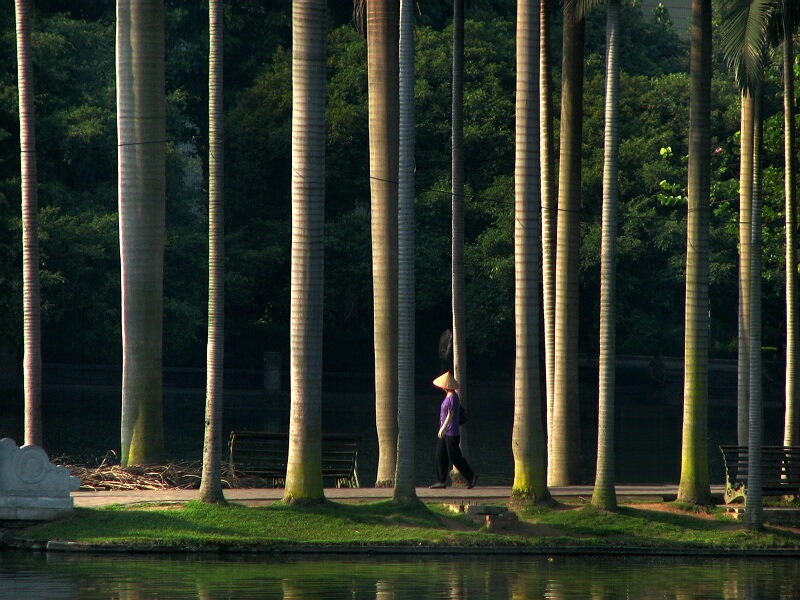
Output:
[451, 0, 469, 466]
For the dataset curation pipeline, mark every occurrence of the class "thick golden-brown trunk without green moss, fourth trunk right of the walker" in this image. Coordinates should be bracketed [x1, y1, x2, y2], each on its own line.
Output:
[548, 1, 585, 485]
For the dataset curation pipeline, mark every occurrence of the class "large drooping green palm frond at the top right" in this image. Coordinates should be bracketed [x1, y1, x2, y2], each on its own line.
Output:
[720, 0, 779, 94]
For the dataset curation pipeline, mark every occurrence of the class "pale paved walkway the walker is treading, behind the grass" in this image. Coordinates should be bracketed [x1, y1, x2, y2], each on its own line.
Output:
[72, 484, 723, 507]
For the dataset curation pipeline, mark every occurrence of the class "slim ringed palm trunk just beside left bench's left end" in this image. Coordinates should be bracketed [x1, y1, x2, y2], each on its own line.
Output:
[200, 0, 225, 502]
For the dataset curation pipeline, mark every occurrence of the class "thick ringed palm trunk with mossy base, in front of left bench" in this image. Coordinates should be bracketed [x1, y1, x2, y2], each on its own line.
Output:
[283, 0, 327, 503]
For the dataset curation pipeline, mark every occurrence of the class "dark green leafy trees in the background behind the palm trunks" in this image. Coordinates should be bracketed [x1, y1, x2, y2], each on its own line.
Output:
[0, 0, 783, 378]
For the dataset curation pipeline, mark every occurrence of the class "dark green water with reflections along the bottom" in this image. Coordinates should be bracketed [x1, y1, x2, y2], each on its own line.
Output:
[0, 553, 800, 600]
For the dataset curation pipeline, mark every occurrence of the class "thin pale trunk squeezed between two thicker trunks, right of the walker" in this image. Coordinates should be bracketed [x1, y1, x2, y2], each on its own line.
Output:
[539, 0, 556, 464]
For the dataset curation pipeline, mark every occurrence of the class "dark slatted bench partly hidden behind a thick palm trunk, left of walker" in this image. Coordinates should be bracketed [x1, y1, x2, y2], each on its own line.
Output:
[228, 431, 361, 487]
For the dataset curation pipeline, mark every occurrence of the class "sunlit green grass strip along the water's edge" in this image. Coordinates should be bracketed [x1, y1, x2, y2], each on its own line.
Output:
[14, 501, 800, 550]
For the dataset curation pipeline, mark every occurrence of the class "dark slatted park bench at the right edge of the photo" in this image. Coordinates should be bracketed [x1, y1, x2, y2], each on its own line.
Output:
[719, 446, 800, 504]
